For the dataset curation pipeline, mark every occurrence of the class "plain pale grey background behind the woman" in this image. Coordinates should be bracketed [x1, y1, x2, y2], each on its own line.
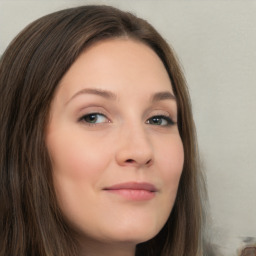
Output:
[0, 0, 256, 256]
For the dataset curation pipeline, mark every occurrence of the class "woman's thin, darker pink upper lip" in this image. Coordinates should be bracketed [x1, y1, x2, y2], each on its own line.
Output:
[104, 182, 157, 192]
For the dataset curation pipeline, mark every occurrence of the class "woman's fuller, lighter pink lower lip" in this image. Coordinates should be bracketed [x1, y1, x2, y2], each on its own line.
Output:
[106, 189, 155, 201]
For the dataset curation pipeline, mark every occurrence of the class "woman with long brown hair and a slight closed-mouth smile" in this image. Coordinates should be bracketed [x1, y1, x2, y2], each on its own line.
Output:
[0, 6, 208, 256]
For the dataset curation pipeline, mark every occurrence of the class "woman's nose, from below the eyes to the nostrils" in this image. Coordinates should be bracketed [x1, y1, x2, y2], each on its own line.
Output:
[116, 124, 153, 168]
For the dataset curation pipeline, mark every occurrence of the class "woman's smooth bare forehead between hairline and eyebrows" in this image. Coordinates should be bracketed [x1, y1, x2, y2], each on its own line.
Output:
[59, 38, 172, 101]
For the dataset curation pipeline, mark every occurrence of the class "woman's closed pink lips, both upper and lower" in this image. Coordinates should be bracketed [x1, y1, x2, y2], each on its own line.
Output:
[103, 182, 158, 201]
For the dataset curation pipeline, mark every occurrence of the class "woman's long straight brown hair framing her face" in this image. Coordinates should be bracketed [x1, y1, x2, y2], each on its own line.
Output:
[0, 6, 204, 256]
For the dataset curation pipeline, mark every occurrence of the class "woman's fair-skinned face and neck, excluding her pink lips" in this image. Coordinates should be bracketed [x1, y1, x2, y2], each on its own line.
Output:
[46, 38, 184, 256]
